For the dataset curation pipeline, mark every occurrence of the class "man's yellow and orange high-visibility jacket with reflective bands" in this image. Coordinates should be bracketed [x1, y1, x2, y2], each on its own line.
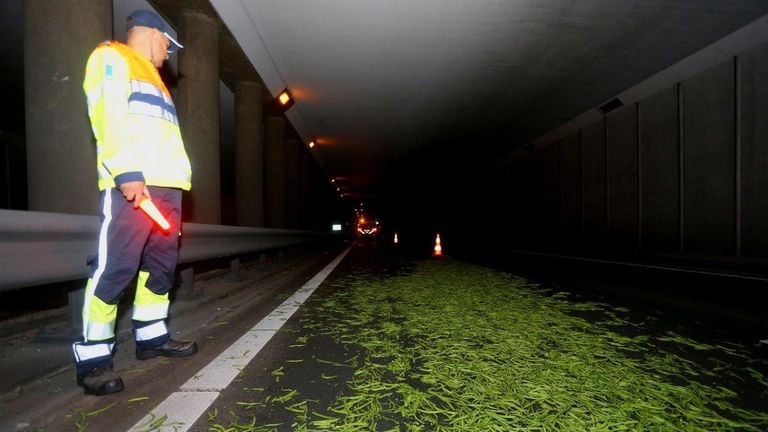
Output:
[83, 41, 192, 190]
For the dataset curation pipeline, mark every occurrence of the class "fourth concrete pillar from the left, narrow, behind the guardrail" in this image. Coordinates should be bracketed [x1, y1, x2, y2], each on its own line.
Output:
[264, 117, 287, 228]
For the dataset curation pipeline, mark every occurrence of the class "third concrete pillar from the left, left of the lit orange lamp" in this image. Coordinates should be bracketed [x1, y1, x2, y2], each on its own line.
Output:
[235, 81, 264, 227]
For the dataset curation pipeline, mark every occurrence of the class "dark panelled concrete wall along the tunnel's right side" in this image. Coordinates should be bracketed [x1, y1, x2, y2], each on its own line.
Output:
[493, 44, 768, 264]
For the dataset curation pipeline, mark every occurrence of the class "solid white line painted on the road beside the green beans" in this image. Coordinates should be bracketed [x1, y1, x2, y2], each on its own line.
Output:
[129, 246, 352, 432]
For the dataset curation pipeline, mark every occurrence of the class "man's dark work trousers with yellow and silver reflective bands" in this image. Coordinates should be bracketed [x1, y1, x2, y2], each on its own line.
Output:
[73, 186, 181, 374]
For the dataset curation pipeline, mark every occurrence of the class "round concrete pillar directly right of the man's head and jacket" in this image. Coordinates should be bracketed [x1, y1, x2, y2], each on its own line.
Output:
[174, 12, 221, 224]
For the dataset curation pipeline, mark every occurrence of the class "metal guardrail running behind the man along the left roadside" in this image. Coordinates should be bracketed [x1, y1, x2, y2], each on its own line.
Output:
[0, 210, 326, 291]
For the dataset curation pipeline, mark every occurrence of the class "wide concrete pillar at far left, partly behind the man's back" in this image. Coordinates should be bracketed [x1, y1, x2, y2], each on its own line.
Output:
[24, 0, 112, 215]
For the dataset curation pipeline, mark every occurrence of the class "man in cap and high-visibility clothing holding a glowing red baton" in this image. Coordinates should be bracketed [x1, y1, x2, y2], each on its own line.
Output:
[73, 10, 197, 395]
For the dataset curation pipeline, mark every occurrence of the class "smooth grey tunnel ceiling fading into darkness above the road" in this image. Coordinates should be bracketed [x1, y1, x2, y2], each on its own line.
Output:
[172, 0, 768, 204]
